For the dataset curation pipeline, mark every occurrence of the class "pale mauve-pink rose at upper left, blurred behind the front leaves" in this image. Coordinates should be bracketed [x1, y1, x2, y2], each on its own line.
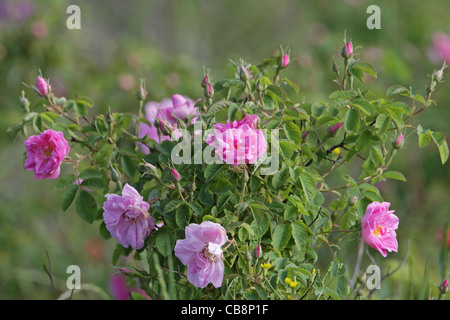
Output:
[138, 94, 198, 154]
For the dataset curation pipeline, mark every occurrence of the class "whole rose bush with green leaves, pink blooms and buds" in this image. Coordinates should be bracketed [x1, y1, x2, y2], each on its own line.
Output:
[9, 40, 448, 299]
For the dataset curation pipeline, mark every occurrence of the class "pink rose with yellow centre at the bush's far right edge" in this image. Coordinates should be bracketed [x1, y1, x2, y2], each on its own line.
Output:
[361, 201, 399, 257]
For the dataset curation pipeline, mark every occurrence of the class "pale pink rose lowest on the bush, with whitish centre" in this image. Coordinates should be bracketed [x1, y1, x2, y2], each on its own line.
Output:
[174, 221, 228, 288]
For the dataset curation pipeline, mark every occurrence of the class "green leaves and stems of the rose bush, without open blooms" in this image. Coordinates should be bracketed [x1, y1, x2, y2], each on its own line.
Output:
[8, 35, 449, 299]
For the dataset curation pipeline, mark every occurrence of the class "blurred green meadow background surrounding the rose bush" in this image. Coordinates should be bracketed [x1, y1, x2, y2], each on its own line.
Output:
[0, 0, 450, 299]
